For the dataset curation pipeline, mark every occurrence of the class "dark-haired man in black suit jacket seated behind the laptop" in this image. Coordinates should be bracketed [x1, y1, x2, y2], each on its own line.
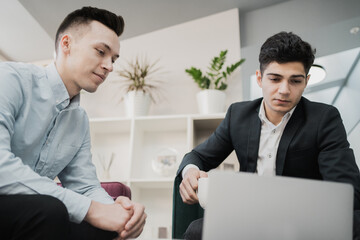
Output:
[177, 32, 360, 239]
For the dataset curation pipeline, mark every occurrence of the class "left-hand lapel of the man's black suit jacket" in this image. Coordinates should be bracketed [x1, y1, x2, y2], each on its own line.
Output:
[246, 105, 261, 172]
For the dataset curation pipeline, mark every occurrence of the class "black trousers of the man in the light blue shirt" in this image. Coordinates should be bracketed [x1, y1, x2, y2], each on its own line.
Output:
[0, 195, 117, 240]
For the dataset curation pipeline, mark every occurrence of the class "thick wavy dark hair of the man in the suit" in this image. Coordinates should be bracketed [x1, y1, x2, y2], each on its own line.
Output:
[259, 32, 316, 75]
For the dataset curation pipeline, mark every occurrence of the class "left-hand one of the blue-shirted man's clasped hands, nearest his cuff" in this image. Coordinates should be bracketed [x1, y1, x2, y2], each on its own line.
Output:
[84, 201, 134, 235]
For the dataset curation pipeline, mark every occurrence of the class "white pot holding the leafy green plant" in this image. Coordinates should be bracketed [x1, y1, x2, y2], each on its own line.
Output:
[196, 89, 226, 114]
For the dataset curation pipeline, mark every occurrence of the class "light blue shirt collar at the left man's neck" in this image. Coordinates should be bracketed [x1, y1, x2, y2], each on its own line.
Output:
[46, 63, 70, 110]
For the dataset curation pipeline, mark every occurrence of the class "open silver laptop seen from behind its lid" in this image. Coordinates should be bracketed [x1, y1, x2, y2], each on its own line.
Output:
[203, 171, 354, 240]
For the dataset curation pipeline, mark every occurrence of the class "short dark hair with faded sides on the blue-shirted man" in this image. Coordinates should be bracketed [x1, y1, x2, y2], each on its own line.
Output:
[55, 7, 125, 50]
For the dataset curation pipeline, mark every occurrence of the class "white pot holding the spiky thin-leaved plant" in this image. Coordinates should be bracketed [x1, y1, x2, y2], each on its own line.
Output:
[124, 91, 151, 117]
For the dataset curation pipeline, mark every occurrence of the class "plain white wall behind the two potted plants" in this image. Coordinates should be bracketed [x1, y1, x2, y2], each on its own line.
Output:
[81, 9, 242, 117]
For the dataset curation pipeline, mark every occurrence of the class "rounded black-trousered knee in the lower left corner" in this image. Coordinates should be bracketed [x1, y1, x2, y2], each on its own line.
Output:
[2, 195, 70, 240]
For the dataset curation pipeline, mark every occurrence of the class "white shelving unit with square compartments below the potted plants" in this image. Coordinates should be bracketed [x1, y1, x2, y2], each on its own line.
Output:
[90, 114, 236, 239]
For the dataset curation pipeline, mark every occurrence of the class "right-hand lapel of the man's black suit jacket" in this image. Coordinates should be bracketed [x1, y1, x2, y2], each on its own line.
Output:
[276, 99, 305, 175]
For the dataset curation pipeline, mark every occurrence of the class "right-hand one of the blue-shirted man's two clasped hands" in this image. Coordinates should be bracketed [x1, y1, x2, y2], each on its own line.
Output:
[115, 197, 147, 239]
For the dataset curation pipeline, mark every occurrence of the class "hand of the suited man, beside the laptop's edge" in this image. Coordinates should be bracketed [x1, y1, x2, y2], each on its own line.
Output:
[179, 168, 208, 204]
